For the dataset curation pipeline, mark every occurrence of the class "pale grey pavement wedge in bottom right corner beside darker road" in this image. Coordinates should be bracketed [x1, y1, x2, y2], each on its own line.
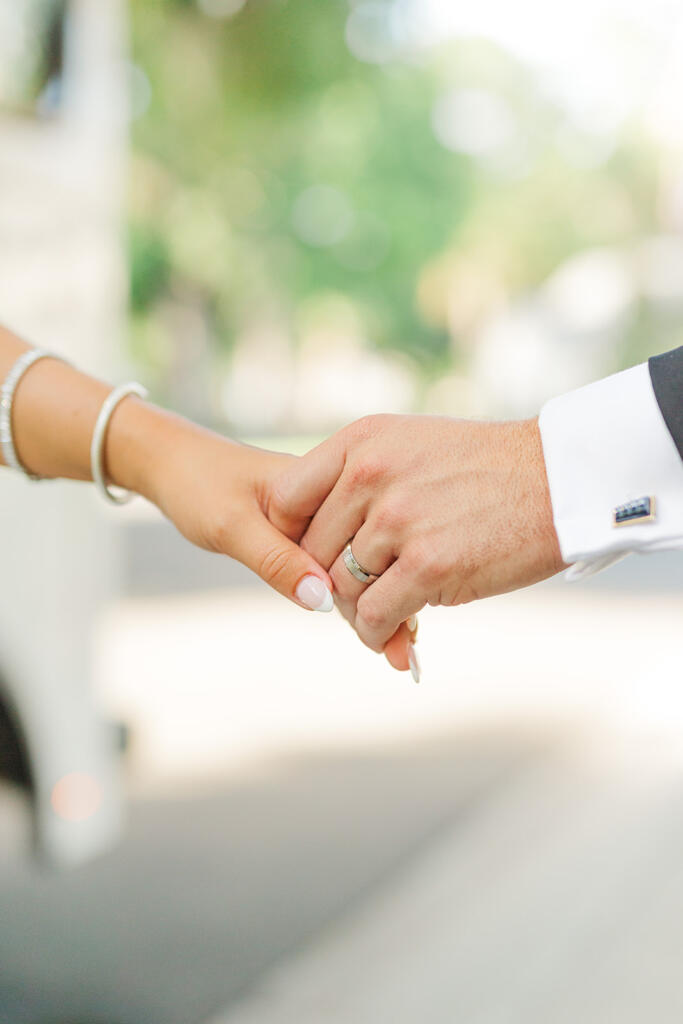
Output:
[211, 742, 683, 1024]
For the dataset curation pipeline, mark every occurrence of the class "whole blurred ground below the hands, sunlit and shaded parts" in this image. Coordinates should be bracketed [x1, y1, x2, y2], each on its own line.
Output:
[0, 559, 683, 1024]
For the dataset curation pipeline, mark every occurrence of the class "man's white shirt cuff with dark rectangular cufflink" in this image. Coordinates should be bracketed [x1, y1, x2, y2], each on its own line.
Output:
[539, 364, 683, 579]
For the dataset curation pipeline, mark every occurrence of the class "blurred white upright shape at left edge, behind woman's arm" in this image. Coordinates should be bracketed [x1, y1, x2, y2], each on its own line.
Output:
[0, 0, 127, 863]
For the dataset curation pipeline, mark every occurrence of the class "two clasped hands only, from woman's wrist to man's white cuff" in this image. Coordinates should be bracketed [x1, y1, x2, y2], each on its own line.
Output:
[150, 405, 564, 681]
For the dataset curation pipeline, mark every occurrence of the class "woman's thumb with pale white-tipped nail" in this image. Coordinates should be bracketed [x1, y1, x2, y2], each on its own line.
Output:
[232, 509, 334, 611]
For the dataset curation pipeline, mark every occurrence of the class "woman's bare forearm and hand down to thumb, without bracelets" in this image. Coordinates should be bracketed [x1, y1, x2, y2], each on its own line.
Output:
[0, 328, 333, 611]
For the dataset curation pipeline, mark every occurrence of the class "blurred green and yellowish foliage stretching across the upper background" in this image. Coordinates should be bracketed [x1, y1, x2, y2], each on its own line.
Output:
[130, 0, 655, 391]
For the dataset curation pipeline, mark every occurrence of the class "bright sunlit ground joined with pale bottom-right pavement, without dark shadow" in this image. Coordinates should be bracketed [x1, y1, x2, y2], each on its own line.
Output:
[92, 560, 683, 1024]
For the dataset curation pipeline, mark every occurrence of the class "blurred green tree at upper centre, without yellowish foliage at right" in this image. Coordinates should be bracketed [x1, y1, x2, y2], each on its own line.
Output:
[126, 0, 473, 374]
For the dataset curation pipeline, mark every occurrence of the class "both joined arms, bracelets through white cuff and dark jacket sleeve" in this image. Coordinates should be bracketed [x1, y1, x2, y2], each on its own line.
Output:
[5, 327, 683, 680]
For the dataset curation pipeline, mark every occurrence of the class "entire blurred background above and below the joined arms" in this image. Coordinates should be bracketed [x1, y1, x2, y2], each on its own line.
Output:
[0, 0, 683, 1024]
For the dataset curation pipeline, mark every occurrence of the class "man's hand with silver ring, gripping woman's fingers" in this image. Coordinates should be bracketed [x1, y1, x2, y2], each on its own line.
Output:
[268, 416, 564, 668]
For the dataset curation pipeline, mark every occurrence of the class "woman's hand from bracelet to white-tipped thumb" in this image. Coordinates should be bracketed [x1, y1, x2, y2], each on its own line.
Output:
[106, 398, 333, 611]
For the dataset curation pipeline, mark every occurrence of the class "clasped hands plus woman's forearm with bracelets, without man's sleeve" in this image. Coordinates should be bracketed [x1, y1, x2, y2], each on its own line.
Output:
[0, 328, 563, 680]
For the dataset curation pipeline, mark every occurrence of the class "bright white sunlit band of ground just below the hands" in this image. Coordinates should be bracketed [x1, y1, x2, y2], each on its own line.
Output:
[96, 556, 683, 795]
